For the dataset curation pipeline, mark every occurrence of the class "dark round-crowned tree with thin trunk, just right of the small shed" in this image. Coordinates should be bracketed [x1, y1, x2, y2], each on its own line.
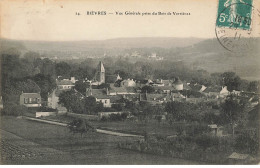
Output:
[221, 95, 246, 136]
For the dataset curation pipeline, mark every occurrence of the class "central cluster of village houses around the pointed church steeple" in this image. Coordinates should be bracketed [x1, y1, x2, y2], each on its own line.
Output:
[80, 62, 233, 107]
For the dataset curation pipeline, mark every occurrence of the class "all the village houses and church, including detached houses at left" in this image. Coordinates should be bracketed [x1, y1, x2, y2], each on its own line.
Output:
[20, 62, 258, 116]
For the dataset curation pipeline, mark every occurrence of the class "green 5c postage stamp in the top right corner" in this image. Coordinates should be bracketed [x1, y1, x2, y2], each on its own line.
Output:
[216, 0, 253, 30]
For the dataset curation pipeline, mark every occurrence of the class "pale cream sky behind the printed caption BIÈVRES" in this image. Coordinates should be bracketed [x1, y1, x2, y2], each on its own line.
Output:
[0, 0, 258, 41]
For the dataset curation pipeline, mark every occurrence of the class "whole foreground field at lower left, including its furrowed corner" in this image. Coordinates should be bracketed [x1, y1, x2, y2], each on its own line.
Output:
[1, 117, 202, 164]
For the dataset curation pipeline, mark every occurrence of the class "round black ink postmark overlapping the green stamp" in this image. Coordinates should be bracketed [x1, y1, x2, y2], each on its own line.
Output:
[215, 3, 260, 52]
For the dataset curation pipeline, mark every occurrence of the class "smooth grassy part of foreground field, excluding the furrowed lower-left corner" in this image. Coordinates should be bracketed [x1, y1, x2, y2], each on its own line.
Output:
[1, 117, 199, 164]
